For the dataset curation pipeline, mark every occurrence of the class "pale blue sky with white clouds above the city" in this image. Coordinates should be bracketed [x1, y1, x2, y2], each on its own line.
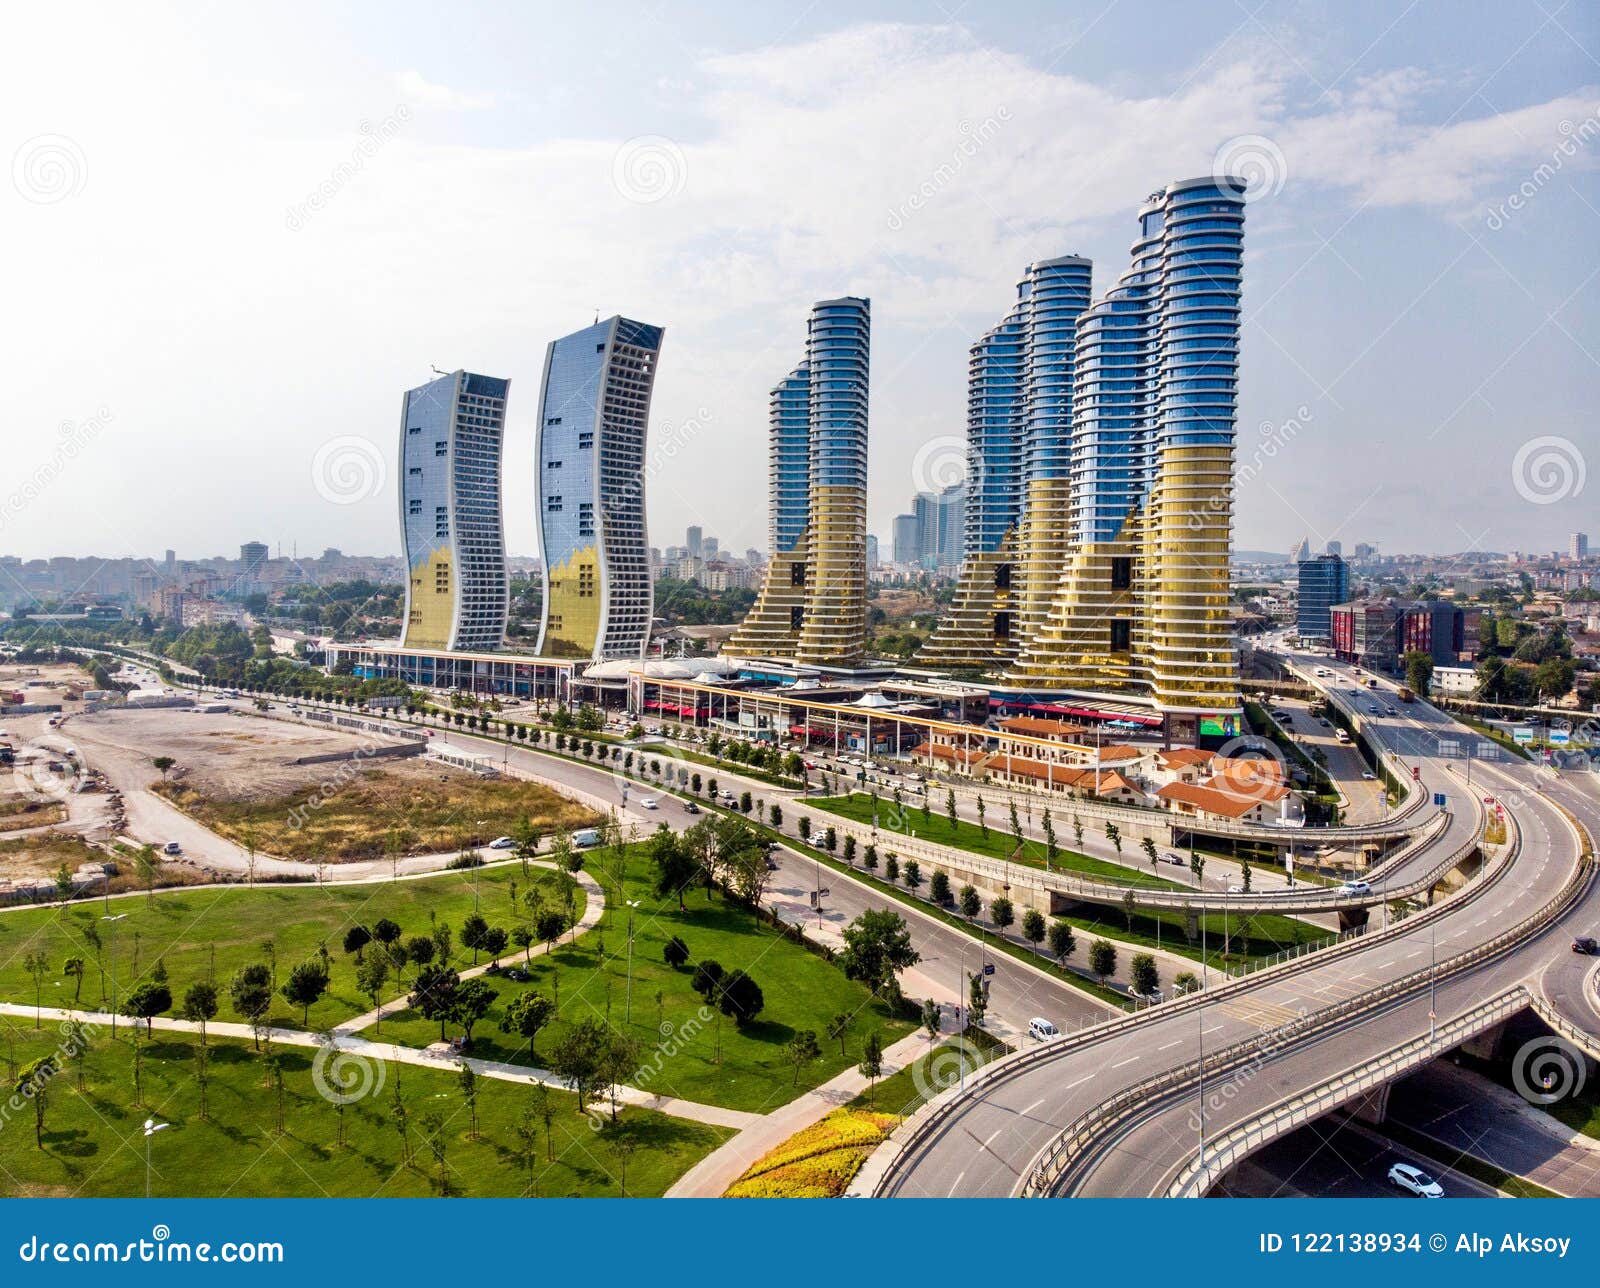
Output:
[0, 0, 1600, 558]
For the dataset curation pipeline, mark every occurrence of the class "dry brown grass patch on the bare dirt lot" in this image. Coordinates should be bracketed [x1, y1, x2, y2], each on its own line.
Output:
[155, 765, 600, 862]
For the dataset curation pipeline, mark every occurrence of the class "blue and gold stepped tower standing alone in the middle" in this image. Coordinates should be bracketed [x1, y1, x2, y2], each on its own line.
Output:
[726, 296, 872, 666]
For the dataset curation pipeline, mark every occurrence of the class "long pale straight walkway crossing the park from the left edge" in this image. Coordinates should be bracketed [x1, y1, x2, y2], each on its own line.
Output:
[0, 1002, 760, 1130]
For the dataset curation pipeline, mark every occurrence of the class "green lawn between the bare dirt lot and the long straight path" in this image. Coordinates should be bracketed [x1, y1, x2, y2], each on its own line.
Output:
[0, 864, 547, 1030]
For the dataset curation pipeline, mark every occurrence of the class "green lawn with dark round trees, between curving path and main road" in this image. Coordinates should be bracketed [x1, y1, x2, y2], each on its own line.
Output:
[369, 846, 914, 1112]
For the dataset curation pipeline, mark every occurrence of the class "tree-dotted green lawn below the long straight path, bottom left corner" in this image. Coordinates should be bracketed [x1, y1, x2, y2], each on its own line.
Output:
[0, 1019, 720, 1197]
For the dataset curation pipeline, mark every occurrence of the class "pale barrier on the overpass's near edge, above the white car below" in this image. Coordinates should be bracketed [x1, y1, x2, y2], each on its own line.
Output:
[1166, 984, 1533, 1198]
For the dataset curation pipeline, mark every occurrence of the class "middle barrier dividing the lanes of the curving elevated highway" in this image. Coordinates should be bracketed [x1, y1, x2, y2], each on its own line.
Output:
[1024, 806, 1594, 1194]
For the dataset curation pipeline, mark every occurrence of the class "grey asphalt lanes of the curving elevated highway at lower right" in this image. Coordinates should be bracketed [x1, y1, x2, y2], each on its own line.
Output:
[886, 649, 1600, 1195]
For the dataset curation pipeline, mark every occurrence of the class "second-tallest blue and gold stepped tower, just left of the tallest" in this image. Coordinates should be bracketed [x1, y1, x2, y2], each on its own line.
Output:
[918, 254, 1091, 670]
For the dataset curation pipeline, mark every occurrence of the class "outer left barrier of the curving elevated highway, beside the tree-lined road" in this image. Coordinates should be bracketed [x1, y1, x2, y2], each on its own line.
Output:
[861, 803, 1522, 1197]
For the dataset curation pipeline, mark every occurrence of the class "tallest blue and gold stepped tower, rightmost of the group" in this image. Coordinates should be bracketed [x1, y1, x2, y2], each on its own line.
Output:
[1008, 176, 1245, 723]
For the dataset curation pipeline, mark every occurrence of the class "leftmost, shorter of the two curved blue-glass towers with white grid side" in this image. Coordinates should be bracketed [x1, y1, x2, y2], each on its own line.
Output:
[400, 371, 510, 650]
